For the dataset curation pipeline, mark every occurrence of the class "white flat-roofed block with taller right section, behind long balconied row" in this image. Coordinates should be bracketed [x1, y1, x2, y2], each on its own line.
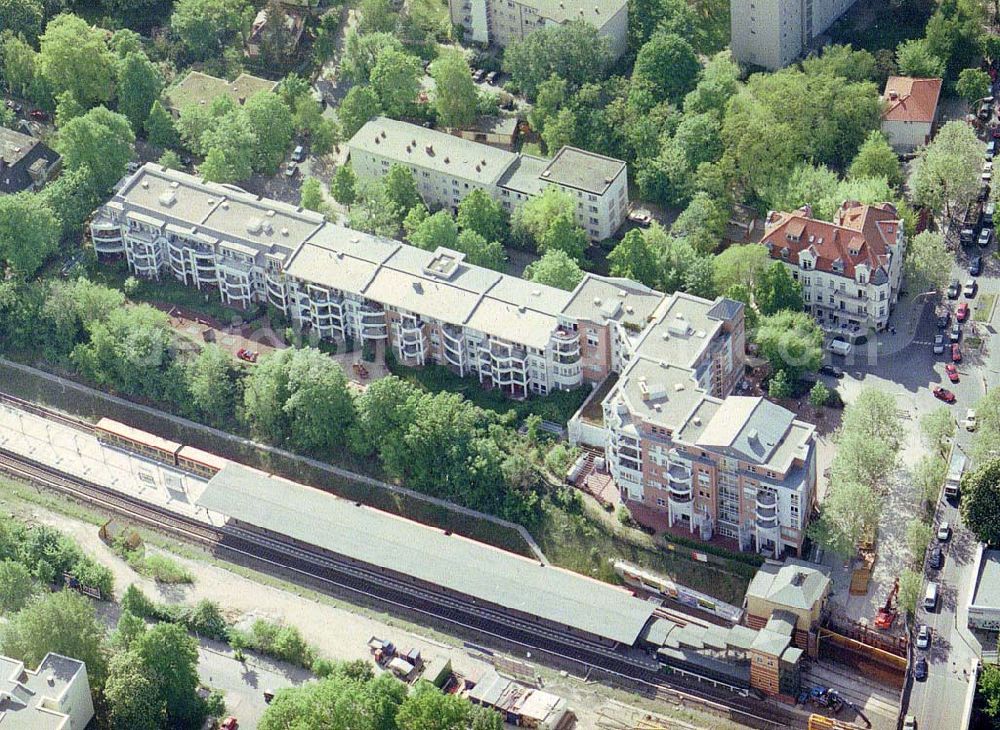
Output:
[347, 117, 628, 241]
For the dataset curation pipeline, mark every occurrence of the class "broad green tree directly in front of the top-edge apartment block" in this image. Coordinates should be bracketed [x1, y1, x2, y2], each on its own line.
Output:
[503, 20, 611, 98]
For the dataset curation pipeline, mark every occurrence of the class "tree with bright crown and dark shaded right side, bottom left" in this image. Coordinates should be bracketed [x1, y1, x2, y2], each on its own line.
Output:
[131, 623, 206, 727]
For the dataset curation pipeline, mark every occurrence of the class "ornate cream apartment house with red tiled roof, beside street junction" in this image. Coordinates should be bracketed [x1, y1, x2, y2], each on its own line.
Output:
[761, 201, 906, 334]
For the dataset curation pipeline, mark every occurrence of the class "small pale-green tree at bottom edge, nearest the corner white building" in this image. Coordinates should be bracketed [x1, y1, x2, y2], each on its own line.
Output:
[104, 648, 167, 730]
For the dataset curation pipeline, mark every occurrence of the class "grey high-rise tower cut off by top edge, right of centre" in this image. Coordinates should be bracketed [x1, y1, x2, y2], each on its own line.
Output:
[729, 0, 855, 71]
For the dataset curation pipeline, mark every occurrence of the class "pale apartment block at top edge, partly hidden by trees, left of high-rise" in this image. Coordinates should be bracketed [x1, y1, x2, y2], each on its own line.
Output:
[448, 0, 628, 58]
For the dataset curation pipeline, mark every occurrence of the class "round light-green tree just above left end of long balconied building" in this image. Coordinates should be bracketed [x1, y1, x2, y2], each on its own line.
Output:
[55, 106, 135, 195]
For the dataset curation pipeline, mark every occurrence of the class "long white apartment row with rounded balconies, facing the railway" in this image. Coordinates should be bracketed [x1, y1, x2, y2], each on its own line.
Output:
[90, 164, 644, 397]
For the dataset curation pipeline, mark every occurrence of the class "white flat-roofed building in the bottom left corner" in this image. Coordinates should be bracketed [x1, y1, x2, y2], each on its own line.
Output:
[0, 653, 94, 730]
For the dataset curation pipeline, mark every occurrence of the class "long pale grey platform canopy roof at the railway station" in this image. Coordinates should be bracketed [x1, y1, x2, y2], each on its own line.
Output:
[198, 464, 655, 645]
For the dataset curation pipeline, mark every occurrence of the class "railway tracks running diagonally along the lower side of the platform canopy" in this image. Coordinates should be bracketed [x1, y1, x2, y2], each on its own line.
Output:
[0, 440, 802, 728]
